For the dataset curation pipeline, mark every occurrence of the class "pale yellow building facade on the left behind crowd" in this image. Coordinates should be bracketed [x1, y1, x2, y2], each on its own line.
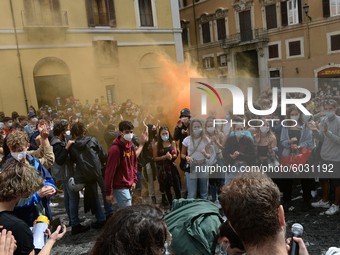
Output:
[0, 0, 183, 114]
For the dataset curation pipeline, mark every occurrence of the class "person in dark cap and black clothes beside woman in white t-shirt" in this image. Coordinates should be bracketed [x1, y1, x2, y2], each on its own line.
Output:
[174, 108, 191, 171]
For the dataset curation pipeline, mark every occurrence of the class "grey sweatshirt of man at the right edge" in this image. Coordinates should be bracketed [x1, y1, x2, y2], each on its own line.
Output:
[313, 116, 340, 162]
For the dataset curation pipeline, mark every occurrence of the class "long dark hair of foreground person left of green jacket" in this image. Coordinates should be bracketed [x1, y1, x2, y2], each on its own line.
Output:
[92, 204, 169, 255]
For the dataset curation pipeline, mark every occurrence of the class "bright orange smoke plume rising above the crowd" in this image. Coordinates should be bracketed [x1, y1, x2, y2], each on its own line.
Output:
[158, 54, 202, 128]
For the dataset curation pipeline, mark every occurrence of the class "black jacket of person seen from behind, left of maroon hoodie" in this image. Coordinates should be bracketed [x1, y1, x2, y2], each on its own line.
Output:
[70, 136, 107, 183]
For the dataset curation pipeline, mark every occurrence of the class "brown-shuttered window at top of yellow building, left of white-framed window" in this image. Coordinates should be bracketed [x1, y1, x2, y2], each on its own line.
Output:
[85, 0, 117, 27]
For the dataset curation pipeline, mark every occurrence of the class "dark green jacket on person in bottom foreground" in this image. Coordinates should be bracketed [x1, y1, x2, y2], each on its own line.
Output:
[165, 199, 223, 255]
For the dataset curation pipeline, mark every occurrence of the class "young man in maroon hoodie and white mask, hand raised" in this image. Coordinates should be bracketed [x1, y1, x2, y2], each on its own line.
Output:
[105, 120, 148, 209]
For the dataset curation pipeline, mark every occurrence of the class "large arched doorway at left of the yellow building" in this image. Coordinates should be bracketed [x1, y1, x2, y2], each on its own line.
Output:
[33, 57, 73, 107]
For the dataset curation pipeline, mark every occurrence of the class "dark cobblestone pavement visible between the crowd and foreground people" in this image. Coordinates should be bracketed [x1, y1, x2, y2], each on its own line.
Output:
[51, 180, 340, 255]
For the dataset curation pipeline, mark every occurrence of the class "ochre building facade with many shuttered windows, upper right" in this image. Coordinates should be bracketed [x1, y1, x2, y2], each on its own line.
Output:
[179, 0, 340, 94]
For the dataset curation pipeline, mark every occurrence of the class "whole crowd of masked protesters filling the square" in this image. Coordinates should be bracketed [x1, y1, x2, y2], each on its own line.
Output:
[0, 86, 340, 255]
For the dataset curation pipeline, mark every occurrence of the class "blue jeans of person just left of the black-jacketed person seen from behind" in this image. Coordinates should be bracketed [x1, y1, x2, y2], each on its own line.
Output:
[63, 181, 80, 227]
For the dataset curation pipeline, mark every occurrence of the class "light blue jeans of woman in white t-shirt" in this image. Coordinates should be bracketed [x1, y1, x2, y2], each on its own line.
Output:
[185, 170, 209, 200]
